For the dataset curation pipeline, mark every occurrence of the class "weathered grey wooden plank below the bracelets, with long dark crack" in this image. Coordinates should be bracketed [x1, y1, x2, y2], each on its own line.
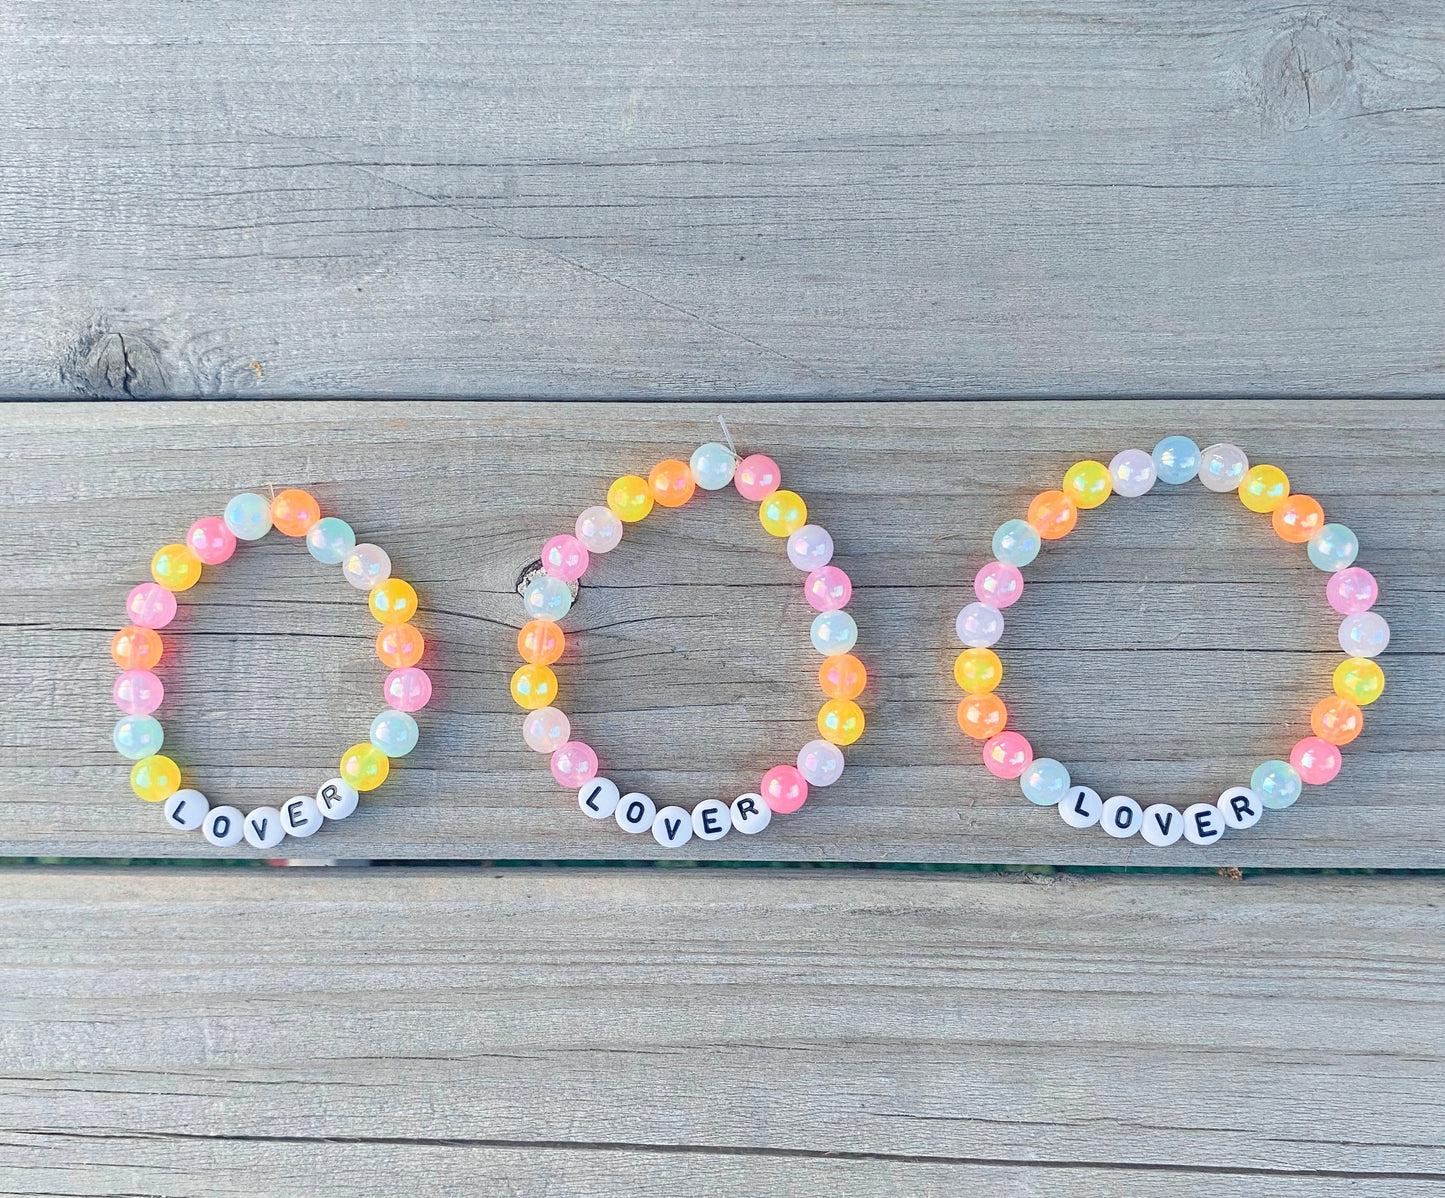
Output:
[0, 870, 1445, 1195]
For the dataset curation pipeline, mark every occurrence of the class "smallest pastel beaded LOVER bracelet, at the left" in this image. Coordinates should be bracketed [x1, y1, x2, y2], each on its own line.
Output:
[110, 490, 432, 848]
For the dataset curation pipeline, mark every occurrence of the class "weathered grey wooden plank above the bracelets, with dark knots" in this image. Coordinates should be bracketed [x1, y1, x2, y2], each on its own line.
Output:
[0, 0, 1445, 397]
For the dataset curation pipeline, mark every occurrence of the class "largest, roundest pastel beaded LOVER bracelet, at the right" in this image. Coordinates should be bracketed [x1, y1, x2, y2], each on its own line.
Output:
[954, 436, 1390, 847]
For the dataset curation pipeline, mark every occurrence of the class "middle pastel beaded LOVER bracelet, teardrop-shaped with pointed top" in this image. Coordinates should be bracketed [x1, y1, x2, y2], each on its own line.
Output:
[512, 425, 867, 848]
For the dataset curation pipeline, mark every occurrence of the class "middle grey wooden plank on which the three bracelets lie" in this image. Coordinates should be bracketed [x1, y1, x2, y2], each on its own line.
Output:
[0, 403, 1445, 867]
